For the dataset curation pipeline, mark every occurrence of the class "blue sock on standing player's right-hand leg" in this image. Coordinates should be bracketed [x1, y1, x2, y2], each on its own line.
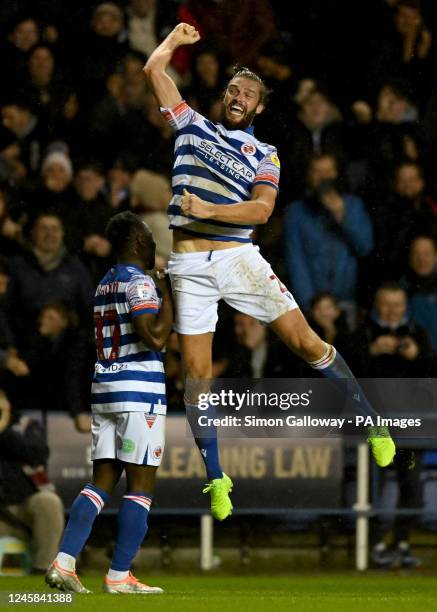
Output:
[111, 492, 152, 572]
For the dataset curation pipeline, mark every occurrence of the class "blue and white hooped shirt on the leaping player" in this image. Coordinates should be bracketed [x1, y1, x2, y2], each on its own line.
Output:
[161, 100, 280, 243]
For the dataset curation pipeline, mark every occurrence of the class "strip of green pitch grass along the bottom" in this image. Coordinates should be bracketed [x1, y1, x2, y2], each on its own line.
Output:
[0, 573, 437, 612]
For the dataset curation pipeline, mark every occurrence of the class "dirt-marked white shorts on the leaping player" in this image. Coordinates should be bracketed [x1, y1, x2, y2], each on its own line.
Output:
[168, 244, 298, 335]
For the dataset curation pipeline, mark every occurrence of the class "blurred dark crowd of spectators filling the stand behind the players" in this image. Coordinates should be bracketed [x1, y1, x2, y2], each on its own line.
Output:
[0, 0, 437, 572]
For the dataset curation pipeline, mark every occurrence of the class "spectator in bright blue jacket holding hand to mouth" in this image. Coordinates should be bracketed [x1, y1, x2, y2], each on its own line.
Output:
[283, 153, 373, 322]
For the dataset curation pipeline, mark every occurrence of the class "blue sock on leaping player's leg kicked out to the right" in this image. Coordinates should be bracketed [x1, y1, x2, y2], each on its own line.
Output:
[309, 345, 378, 422]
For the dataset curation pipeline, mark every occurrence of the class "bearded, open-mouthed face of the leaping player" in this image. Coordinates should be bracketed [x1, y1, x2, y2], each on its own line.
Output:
[222, 77, 264, 130]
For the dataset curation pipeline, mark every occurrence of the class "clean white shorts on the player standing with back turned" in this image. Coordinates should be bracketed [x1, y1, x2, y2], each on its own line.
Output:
[91, 412, 165, 466]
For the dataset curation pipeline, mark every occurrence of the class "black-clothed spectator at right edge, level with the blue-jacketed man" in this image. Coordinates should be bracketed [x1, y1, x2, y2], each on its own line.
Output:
[372, 162, 437, 282]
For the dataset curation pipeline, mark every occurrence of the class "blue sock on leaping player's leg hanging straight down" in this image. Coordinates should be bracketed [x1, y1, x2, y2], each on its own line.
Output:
[185, 403, 223, 480]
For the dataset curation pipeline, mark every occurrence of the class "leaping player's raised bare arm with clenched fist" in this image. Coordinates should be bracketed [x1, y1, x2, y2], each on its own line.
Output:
[143, 23, 200, 108]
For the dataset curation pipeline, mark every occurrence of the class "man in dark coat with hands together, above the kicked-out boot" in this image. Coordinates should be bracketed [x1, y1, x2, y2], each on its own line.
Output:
[363, 283, 437, 378]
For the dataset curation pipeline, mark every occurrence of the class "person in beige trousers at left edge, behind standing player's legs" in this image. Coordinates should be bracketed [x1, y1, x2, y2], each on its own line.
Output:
[0, 390, 64, 574]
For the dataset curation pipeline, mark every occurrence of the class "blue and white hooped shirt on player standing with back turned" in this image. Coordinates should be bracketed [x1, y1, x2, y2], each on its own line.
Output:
[91, 265, 167, 414]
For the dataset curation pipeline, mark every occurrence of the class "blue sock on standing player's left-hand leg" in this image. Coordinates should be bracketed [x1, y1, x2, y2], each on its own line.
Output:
[59, 484, 110, 558]
